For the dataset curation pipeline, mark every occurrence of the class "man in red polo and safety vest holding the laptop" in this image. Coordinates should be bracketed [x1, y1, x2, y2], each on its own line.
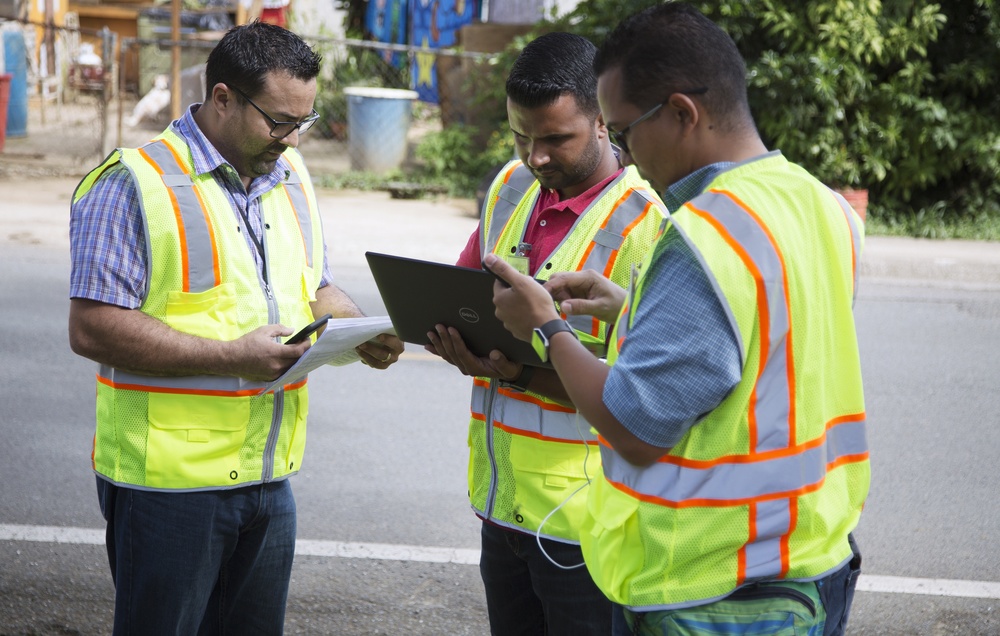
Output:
[428, 33, 663, 636]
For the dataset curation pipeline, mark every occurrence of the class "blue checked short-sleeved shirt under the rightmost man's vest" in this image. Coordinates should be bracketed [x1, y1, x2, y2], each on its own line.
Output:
[604, 163, 742, 448]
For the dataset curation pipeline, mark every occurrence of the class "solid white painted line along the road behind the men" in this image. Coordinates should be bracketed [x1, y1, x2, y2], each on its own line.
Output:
[0, 524, 1000, 599]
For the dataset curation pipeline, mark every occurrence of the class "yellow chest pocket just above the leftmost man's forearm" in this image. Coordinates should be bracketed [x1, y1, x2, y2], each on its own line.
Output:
[163, 283, 243, 340]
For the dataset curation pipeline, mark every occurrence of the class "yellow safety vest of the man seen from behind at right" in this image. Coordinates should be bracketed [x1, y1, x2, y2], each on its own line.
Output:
[581, 153, 870, 611]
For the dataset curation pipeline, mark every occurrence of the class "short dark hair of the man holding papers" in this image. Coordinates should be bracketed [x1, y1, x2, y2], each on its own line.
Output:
[205, 20, 321, 101]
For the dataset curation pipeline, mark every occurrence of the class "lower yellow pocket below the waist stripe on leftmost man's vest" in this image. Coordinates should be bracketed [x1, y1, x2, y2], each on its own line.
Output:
[146, 393, 252, 488]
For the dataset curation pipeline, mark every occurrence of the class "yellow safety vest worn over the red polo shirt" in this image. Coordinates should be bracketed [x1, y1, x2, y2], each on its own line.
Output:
[469, 161, 665, 543]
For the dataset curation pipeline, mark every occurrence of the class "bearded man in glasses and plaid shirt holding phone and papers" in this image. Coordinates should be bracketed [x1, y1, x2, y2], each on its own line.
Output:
[69, 23, 402, 636]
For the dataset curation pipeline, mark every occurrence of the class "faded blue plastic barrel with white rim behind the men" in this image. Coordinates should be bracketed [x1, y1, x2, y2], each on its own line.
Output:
[344, 86, 417, 172]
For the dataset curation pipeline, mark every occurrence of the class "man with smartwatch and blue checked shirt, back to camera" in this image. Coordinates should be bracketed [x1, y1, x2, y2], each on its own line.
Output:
[484, 3, 870, 635]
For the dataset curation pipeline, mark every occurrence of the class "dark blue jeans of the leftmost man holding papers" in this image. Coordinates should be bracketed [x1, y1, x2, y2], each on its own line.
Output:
[97, 477, 295, 636]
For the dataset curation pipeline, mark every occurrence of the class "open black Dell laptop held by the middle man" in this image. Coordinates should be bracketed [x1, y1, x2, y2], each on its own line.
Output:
[365, 252, 552, 367]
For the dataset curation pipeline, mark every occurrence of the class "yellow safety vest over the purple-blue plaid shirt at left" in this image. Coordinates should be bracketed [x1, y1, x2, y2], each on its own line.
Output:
[74, 130, 323, 490]
